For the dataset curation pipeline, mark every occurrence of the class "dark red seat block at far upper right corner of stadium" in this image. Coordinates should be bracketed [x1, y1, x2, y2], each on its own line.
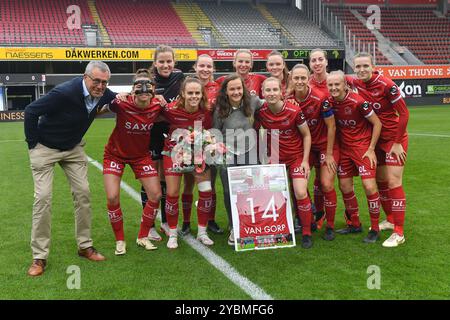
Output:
[359, 8, 450, 64]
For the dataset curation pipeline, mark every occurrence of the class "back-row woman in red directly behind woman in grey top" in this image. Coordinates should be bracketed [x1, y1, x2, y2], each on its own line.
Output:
[216, 49, 266, 98]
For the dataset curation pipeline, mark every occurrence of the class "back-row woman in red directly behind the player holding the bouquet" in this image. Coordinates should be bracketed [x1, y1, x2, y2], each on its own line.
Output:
[180, 54, 223, 236]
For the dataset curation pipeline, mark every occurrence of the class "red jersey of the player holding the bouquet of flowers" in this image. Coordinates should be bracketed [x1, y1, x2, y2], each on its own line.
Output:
[162, 101, 212, 151]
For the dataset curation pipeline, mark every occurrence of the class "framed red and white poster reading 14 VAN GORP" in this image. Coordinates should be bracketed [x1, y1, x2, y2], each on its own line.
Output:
[227, 164, 295, 251]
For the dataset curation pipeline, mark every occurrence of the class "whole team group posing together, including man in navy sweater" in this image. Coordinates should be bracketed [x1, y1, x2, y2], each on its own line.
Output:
[24, 45, 409, 276]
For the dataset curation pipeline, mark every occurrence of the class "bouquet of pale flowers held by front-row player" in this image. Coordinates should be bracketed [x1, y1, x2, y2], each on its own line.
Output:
[162, 127, 227, 173]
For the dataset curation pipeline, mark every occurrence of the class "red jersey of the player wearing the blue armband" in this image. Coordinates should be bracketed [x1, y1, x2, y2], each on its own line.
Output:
[287, 88, 333, 149]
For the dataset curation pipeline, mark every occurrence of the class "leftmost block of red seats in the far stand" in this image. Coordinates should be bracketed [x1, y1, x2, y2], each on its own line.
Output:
[0, 0, 93, 45]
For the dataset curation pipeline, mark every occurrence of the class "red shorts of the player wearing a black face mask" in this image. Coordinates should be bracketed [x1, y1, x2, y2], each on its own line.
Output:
[103, 154, 158, 179]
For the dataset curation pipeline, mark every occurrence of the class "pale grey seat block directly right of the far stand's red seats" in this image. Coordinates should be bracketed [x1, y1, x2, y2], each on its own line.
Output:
[199, 2, 281, 47]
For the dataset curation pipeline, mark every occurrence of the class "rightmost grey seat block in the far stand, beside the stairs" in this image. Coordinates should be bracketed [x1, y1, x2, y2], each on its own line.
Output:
[266, 4, 336, 48]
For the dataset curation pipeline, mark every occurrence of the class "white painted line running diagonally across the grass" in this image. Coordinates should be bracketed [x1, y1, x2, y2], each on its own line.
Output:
[87, 156, 274, 300]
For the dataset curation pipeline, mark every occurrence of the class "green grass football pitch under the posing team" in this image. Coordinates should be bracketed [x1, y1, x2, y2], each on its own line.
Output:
[0, 106, 450, 300]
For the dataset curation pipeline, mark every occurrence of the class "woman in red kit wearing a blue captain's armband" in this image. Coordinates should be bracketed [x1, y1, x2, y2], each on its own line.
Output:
[287, 64, 339, 241]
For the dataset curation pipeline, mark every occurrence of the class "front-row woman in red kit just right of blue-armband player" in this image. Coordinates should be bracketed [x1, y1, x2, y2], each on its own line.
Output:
[327, 71, 381, 243]
